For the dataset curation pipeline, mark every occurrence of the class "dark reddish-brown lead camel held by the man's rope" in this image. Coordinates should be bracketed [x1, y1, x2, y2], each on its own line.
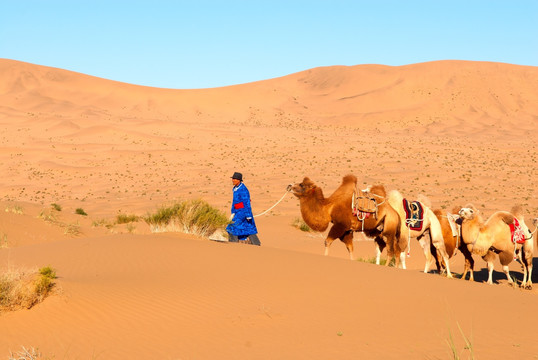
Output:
[291, 175, 399, 263]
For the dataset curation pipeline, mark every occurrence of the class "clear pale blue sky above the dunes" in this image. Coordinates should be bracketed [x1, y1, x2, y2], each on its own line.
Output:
[0, 0, 538, 89]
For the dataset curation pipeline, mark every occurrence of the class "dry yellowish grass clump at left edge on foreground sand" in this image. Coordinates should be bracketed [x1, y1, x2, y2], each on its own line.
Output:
[0, 266, 56, 313]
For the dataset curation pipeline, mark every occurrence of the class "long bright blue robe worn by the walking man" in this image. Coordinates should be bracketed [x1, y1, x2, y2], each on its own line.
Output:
[226, 183, 258, 240]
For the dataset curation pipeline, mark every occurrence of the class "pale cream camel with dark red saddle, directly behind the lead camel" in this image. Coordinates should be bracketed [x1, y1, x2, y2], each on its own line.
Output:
[388, 190, 452, 278]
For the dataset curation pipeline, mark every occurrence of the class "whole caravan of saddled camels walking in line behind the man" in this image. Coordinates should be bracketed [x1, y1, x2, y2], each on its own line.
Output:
[289, 175, 538, 289]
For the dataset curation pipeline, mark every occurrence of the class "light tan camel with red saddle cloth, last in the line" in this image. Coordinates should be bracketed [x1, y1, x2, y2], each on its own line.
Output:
[459, 204, 534, 289]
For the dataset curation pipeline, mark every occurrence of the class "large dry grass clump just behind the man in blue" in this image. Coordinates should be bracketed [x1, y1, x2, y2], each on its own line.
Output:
[144, 200, 228, 237]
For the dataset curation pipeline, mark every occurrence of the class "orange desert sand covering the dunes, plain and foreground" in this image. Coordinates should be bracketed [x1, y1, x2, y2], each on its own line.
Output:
[0, 59, 538, 359]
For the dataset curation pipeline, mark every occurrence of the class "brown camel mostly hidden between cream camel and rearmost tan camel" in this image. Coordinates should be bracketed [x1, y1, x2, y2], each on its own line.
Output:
[430, 207, 474, 281]
